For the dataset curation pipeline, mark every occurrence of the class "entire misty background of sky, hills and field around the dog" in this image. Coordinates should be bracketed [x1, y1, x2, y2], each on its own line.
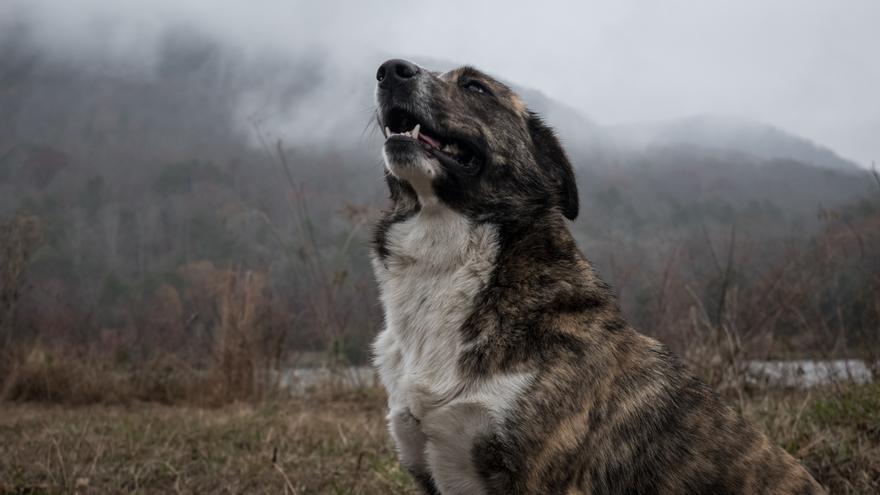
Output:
[0, 4, 880, 494]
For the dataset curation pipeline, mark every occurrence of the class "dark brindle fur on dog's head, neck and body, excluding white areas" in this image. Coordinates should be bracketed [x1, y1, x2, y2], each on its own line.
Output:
[374, 62, 824, 494]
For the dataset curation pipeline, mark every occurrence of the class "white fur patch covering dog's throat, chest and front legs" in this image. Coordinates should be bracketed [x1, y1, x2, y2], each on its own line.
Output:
[373, 193, 533, 493]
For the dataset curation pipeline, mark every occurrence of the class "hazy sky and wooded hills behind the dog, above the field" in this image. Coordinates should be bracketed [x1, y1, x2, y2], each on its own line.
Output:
[0, 0, 880, 369]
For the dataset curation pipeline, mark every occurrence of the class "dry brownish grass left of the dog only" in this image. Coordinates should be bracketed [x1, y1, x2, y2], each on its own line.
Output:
[0, 390, 416, 494]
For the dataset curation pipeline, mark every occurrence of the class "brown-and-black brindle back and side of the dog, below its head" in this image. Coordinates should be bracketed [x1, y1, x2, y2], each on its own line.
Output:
[444, 215, 821, 494]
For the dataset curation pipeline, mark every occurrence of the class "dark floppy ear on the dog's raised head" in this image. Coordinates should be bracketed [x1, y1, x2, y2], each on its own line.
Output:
[527, 112, 578, 220]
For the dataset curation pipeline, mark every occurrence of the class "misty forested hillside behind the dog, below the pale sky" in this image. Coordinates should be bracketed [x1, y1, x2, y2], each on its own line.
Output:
[0, 31, 880, 368]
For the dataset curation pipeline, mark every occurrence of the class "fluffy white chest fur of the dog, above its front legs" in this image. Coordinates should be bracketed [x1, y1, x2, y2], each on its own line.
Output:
[374, 206, 497, 407]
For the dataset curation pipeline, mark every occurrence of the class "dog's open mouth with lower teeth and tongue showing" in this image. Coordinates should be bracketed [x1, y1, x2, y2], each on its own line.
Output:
[385, 109, 484, 170]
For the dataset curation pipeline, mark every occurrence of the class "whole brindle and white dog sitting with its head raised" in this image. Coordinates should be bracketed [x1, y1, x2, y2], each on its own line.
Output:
[373, 60, 822, 494]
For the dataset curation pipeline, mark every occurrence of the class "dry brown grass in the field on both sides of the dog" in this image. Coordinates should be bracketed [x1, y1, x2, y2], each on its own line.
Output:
[0, 384, 880, 494]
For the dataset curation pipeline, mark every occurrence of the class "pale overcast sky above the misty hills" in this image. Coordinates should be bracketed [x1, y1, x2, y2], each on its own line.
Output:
[6, 0, 880, 166]
